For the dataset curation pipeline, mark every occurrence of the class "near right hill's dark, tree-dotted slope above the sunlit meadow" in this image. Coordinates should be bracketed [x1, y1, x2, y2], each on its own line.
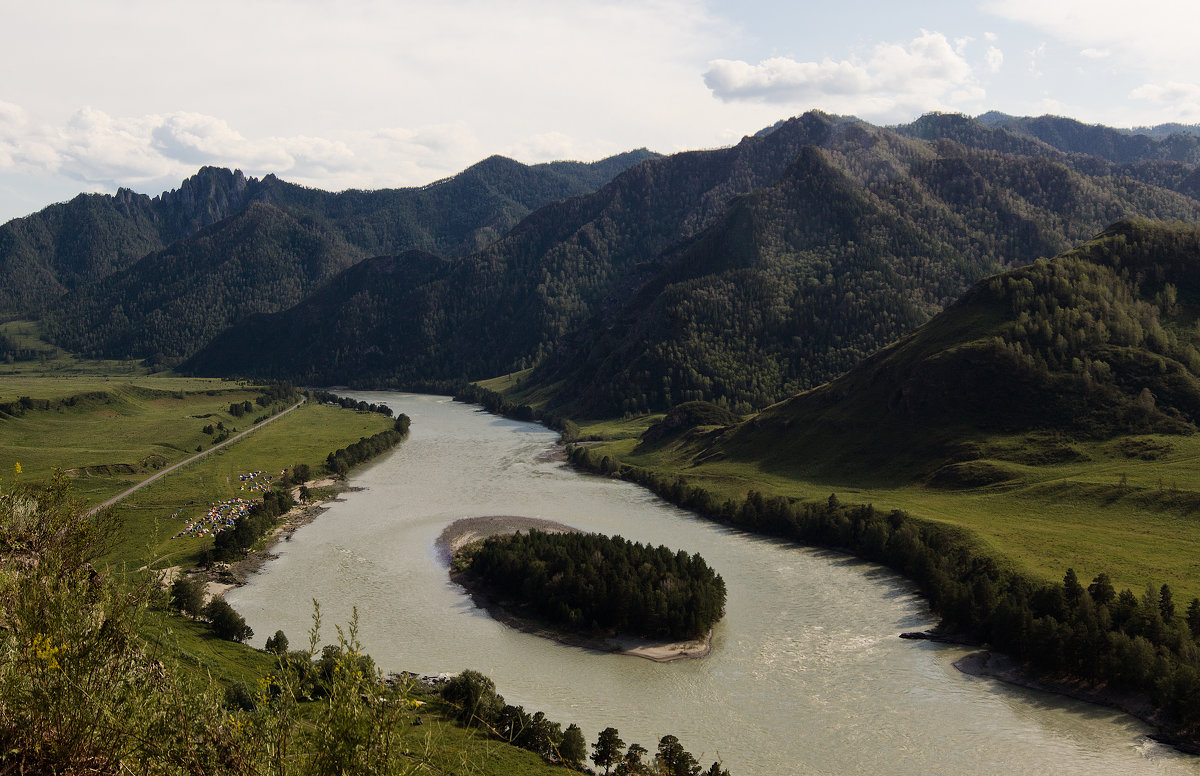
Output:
[703, 221, 1200, 476]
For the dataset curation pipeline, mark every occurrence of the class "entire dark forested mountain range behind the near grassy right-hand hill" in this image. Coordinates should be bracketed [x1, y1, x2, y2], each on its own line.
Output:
[7, 112, 1200, 415]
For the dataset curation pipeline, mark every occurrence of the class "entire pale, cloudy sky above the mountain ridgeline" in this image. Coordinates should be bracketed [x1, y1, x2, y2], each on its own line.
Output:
[0, 0, 1200, 222]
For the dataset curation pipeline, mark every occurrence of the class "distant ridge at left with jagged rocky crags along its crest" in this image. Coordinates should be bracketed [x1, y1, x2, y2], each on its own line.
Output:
[0, 149, 655, 314]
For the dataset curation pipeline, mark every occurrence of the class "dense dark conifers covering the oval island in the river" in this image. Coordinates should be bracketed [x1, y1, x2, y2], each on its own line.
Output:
[451, 529, 725, 640]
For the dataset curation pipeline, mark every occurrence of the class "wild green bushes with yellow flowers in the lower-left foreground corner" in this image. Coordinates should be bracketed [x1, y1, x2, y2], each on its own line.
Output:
[0, 477, 246, 774]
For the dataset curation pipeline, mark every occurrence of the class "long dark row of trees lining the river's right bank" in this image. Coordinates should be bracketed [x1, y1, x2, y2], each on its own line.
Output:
[570, 447, 1200, 739]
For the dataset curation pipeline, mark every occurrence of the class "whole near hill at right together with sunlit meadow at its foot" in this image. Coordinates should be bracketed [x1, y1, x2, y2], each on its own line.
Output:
[582, 222, 1200, 597]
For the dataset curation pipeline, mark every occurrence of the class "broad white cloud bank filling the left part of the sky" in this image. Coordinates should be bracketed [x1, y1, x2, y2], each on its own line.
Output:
[0, 0, 779, 221]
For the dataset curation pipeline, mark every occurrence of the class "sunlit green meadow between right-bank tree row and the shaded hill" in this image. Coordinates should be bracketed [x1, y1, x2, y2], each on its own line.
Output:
[581, 422, 1200, 601]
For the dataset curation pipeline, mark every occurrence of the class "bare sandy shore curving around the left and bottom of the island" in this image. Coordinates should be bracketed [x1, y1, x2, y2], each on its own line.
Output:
[434, 515, 713, 663]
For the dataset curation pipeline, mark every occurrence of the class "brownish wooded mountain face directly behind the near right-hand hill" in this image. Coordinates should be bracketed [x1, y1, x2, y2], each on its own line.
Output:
[533, 127, 1200, 415]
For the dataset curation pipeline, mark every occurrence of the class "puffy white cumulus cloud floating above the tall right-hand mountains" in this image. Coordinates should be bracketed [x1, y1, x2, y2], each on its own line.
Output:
[704, 31, 982, 115]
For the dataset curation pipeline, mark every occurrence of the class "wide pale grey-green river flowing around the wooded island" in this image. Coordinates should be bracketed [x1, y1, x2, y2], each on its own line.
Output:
[228, 393, 1200, 776]
